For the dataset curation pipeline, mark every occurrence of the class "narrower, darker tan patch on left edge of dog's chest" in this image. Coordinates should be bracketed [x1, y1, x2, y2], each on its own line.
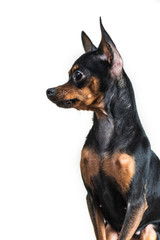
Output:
[80, 148, 100, 187]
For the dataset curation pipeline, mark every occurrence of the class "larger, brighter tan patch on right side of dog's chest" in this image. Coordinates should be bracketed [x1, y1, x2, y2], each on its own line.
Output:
[102, 153, 135, 192]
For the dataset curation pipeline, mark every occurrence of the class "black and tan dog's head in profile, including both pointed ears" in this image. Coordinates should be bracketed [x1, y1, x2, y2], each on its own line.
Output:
[47, 19, 123, 114]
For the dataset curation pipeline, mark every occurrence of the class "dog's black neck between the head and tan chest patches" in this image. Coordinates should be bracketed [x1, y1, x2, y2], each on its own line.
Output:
[92, 73, 142, 152]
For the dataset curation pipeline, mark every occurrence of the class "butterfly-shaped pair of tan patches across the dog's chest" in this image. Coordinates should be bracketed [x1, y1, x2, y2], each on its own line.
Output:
[80, 147, 135, 193]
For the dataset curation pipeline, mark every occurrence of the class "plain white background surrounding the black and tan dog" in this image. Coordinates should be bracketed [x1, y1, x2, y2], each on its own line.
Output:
[0, 0, 160, 240]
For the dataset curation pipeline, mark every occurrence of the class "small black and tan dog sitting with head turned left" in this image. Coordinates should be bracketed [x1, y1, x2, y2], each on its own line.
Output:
[47, 19, 160, 240]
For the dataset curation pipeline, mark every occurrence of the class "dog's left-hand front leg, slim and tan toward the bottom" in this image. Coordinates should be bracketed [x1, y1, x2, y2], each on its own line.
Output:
[86, 194, 106, 240]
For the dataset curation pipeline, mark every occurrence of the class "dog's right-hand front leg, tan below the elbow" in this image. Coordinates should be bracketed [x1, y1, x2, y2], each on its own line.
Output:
[118, 199, 148, 240]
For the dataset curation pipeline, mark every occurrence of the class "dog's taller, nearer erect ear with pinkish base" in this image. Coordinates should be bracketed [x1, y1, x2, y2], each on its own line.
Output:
[98, 18, 123, 78]
